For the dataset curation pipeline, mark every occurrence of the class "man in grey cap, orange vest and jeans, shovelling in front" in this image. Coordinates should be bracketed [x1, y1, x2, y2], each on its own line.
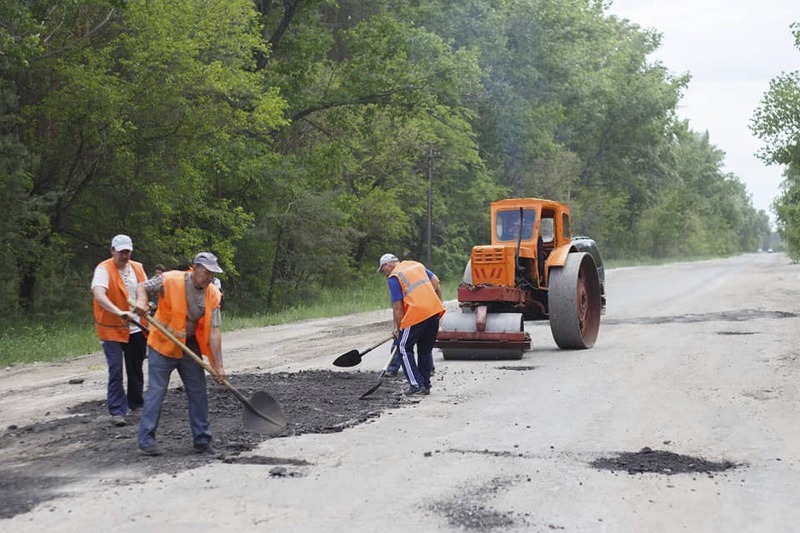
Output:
[136, 252, 225, 455]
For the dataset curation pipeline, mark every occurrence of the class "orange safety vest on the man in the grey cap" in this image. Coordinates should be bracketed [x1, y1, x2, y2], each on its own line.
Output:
[147, 270, 221, 366]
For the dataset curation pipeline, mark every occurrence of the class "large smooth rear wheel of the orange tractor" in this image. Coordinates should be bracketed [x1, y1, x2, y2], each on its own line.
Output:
[548, 252, 602, 350]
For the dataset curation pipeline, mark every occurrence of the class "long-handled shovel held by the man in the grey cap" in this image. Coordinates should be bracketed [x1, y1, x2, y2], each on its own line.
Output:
[129, 308, 287, 434]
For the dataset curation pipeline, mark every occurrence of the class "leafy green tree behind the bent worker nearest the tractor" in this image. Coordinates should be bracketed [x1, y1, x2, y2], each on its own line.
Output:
[231, 7, 492, 306]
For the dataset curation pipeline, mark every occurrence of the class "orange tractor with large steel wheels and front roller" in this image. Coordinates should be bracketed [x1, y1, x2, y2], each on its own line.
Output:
[436, 198, 605, 359]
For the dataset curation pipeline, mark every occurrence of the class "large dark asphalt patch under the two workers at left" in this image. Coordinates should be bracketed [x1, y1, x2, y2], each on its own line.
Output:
[0, 370, 406, 518]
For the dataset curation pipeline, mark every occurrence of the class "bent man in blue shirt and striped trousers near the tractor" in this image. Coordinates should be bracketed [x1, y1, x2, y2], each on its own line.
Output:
[378, 254, 444, 396]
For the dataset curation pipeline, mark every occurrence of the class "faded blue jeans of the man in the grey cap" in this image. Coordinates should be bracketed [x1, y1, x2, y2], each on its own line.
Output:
[138, 338, 211, 448]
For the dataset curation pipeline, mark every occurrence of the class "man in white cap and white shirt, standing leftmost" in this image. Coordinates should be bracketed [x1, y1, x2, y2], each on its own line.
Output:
[91, 235, 147, 427]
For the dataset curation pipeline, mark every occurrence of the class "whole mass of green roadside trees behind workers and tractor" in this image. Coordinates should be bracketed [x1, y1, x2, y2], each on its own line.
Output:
[0, 0, 776, 323]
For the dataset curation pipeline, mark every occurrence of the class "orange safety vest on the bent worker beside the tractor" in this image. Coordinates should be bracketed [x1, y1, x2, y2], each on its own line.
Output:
[389, 261, 444, 329]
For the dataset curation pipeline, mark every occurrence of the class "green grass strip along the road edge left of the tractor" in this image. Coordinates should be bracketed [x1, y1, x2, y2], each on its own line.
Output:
[0, 276, 458, 366]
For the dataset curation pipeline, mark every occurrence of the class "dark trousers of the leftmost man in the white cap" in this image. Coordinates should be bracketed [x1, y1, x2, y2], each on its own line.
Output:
[102, 331, 147, 416]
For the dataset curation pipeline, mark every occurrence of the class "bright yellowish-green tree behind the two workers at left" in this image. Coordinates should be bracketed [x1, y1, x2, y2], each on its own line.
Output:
[5, 0, 284, 314]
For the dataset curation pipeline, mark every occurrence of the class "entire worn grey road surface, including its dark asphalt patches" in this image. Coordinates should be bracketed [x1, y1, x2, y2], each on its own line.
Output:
[0, 254, 800, 532]
